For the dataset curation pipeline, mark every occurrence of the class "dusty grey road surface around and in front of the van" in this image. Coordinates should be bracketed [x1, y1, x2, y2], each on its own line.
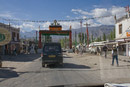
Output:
[0, 54, 130, 87]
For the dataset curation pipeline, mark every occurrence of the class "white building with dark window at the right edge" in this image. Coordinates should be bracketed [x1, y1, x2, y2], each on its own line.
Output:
[115, 13, 130, 56]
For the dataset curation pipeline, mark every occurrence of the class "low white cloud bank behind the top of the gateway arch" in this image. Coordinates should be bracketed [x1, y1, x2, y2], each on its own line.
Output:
[12, 22, 80, 32]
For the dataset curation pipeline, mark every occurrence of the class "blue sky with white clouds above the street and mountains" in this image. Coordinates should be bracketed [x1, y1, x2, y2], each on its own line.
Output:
[0, 0, 130, 30]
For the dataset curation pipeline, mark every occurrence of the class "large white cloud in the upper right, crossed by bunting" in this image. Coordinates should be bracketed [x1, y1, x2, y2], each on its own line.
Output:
[71, 5, 126, 25]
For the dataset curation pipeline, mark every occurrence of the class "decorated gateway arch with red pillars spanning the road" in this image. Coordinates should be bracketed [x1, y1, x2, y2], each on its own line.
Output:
[39, 20, 72, 49]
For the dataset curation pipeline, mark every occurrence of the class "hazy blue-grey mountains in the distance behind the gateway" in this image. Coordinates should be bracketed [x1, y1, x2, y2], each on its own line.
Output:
[20, 25, 114, 40]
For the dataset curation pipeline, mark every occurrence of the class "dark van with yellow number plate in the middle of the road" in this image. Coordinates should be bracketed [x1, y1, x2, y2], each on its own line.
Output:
[41, 43, 63, 67]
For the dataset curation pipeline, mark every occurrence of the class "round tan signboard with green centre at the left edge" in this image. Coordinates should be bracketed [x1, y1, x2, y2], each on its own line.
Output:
[0, 28, 11, 46]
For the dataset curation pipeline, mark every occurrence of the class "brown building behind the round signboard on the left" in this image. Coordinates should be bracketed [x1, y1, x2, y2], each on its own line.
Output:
[0, 23, 20, 55]
